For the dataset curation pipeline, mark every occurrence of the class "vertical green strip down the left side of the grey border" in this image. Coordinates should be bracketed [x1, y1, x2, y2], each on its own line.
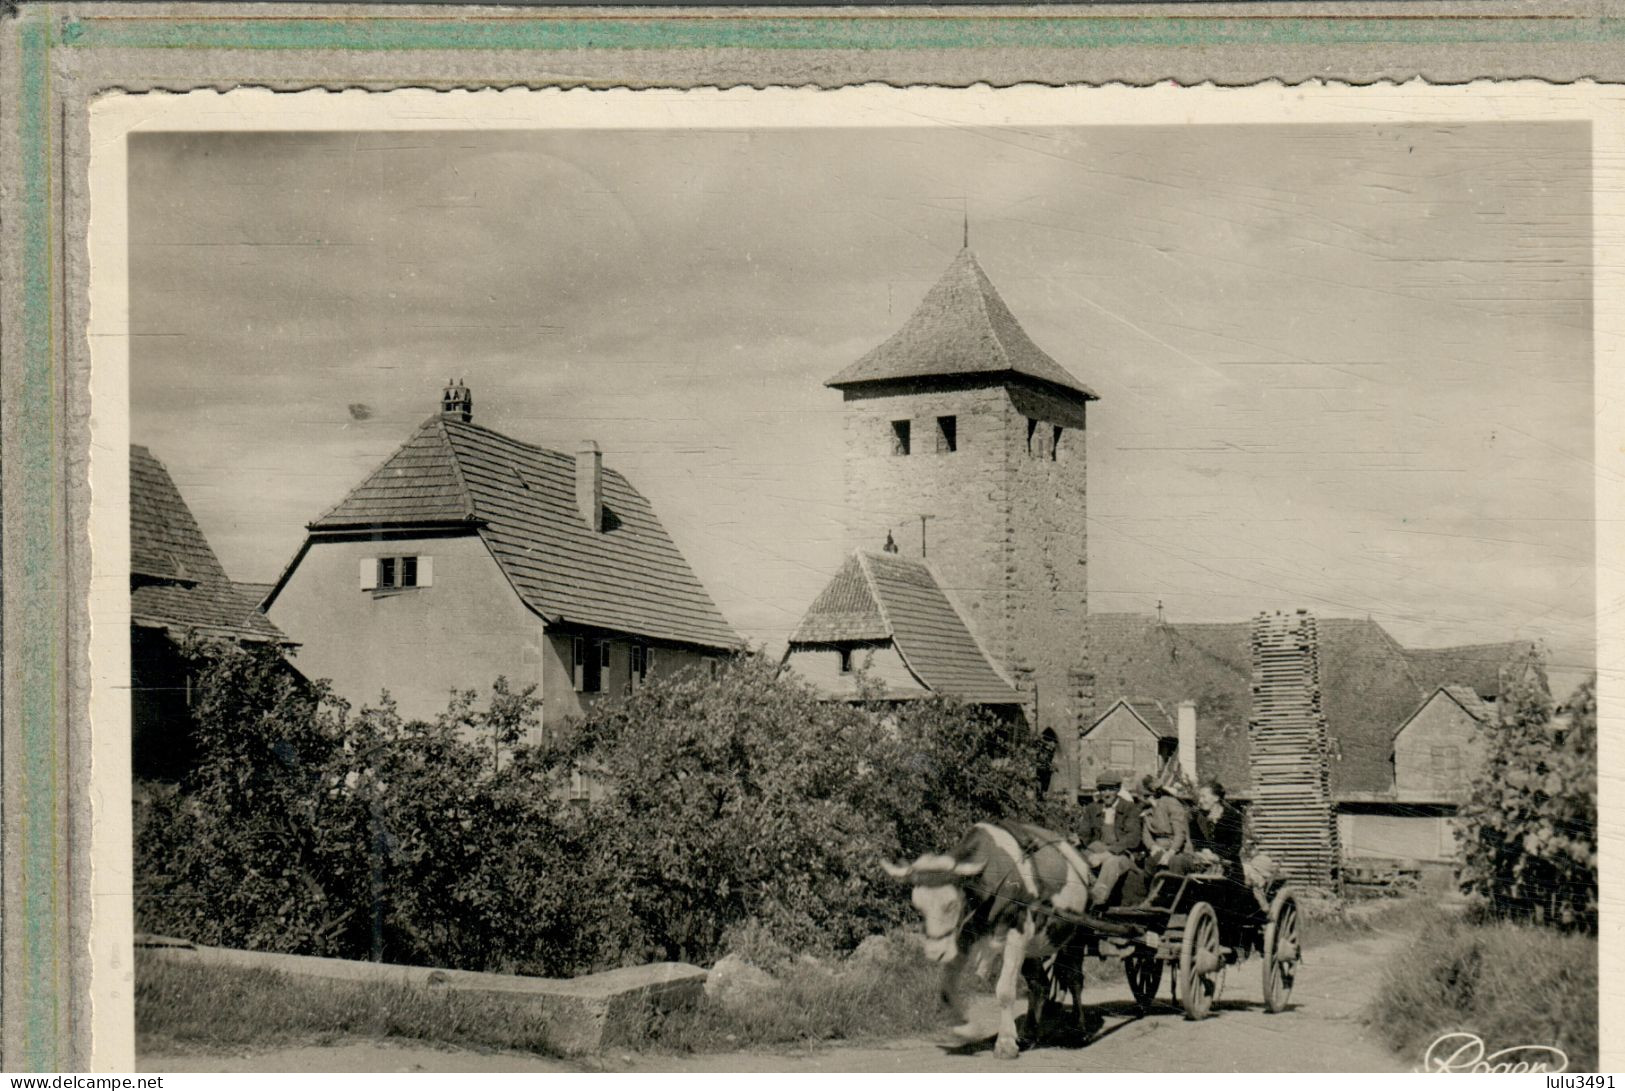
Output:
[14, 12, 68, 1071]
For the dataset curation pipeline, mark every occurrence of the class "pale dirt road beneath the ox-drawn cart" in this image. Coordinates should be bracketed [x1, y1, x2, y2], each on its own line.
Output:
[138, 935, 1415, 1071]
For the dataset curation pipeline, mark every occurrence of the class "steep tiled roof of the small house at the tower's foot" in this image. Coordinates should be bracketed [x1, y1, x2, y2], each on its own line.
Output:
[790, 551, 1021, 704]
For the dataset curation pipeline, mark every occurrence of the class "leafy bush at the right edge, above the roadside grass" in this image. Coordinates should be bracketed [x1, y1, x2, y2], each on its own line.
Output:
[1458, 652, 1597, 932]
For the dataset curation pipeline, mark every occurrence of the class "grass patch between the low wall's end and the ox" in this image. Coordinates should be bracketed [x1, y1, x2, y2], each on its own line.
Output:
[642, 941, 949, 1054]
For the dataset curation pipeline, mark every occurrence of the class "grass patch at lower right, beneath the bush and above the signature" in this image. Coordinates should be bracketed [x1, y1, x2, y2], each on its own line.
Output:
[1367, 919, 1597, 1071]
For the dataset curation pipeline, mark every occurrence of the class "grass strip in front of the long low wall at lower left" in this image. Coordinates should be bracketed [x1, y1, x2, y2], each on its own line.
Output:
[135, 951, 557, 1055]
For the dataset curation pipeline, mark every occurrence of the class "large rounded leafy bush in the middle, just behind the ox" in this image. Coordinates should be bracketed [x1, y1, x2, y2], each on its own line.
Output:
[552, 657, 1035, 961]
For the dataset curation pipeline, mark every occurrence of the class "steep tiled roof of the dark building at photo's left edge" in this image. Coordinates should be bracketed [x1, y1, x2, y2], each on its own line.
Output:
[130, 446, 288, 642]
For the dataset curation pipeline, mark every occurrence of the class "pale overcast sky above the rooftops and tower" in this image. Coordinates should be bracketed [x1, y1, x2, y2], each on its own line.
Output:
[130, 124, 1594, 686]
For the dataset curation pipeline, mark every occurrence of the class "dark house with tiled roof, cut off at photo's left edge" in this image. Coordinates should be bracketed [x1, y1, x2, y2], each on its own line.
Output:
[130, 446, 289, 779]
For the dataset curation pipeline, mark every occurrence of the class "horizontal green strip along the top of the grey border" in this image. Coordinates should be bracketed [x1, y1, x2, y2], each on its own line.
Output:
[59, 15, 1625, 52]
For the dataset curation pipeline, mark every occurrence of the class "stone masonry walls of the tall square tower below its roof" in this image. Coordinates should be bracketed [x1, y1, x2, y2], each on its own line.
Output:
[847, 385, 1094, 793]
